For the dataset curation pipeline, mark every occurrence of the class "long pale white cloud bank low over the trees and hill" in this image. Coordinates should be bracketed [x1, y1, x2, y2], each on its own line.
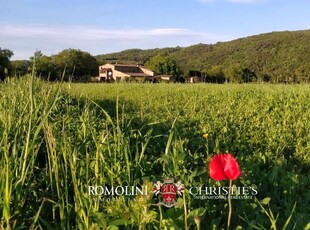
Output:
[0, 23, 233, 59]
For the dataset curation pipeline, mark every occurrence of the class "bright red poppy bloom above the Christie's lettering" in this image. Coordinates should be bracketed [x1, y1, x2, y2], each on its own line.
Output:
[209, 154, 241, 180]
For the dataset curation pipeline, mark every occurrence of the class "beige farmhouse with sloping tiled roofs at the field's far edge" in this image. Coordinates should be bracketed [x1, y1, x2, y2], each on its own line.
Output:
[97, 64, 154, 82]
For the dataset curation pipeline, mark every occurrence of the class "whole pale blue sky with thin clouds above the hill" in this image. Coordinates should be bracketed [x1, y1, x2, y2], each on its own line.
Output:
[0, 0, 310, 60]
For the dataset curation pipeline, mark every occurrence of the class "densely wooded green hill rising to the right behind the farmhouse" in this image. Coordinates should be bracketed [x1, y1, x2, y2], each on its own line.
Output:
[96, 30, 310, 83]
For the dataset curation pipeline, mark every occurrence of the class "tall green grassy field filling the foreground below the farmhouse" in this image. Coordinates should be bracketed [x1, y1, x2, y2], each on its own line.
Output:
[0, 77, 310, 229]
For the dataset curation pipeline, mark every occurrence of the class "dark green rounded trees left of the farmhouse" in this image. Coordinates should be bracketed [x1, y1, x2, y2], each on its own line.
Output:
[0, 49, 99, 82]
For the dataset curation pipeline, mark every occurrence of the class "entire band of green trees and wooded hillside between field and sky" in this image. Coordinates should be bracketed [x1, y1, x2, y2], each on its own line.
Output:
[0, 30, 310, 83]
